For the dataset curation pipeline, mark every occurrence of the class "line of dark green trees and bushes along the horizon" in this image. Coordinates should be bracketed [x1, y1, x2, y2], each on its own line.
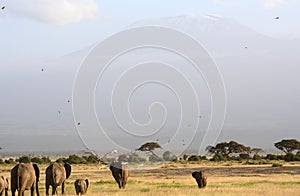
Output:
[0, 139, 300, 164]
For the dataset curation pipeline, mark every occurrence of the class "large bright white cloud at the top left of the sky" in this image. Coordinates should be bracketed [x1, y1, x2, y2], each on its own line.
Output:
[6, 0, 99, 25]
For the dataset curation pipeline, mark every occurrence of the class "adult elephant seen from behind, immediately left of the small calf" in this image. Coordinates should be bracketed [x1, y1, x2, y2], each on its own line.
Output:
[46, 163, 71, 195]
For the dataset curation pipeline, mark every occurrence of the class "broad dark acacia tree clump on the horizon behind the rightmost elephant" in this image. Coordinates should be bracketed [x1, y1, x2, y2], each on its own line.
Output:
[206, 141, 251, 158]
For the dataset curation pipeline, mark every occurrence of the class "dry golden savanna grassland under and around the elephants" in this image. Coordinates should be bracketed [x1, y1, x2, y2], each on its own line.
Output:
[0, 161, 300, 196]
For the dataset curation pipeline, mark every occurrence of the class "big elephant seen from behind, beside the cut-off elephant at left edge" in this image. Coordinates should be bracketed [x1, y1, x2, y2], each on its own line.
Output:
[10, 163, 40, 196]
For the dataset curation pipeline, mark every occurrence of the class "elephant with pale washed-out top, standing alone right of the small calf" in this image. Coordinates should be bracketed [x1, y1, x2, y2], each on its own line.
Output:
[109, 161, 129, 189]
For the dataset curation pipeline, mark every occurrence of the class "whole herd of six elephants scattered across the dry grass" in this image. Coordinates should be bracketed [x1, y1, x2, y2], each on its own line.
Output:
[0, 161, 207, 196]
